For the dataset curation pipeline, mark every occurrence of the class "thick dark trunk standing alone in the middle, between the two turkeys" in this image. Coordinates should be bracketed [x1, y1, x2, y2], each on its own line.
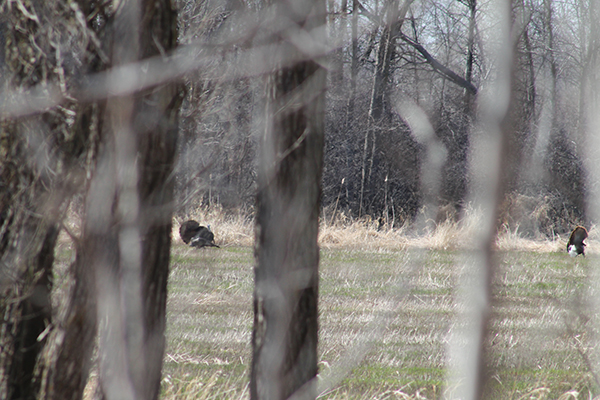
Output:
[250, 0, 325, 400]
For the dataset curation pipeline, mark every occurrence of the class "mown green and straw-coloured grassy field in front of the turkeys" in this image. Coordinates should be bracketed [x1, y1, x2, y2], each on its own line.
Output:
[163, 233, 600, 399]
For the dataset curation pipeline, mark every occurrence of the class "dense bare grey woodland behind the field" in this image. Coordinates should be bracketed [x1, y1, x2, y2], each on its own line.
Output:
[178, 0, 597, 238]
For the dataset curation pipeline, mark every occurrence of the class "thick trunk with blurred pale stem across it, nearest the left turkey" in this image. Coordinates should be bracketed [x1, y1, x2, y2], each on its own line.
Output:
[94, 0, 181, 399]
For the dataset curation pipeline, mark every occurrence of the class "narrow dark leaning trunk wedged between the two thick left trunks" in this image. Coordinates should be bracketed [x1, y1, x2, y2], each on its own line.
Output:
[35, 4, 110, 400]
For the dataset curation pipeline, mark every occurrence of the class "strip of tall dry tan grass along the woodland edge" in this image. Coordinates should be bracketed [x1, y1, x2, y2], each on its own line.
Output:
[173, 207, 600, 254]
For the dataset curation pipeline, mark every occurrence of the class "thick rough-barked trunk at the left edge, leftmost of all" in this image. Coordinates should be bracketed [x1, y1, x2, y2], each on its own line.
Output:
[0, 2, 93, 399]
